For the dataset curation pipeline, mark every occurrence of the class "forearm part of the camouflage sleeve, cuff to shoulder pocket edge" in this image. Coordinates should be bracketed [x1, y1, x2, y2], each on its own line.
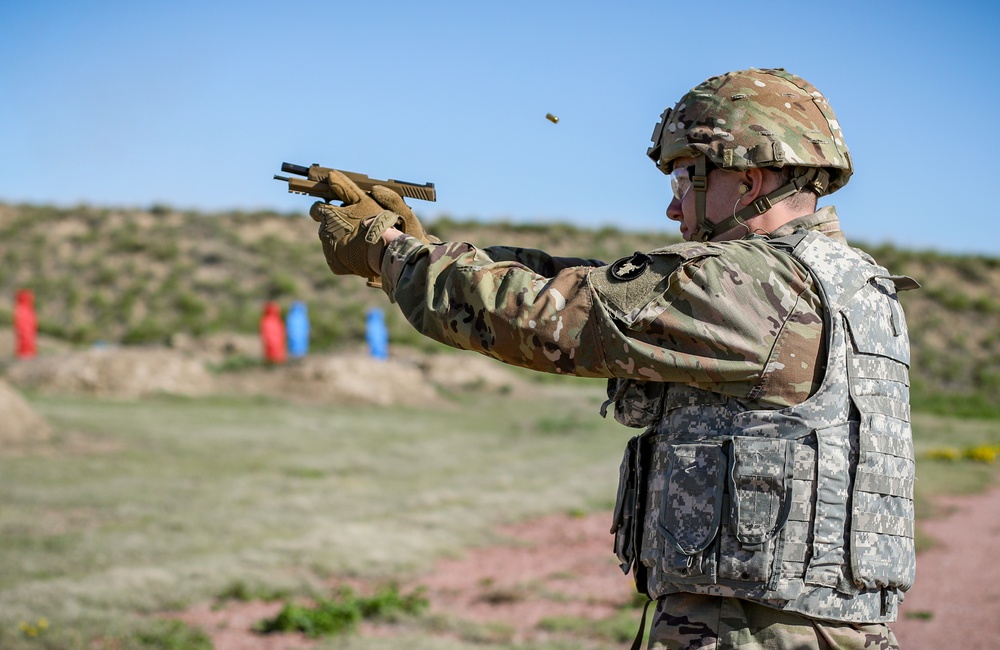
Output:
[382, 237, 611, 377]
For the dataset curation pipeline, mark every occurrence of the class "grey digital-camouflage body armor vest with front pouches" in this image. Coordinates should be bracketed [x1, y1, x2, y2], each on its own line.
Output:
[612, 232, 916, 623]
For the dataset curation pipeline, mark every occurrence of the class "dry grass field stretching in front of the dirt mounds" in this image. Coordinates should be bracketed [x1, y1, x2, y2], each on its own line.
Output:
[0, 342, 1000, 650]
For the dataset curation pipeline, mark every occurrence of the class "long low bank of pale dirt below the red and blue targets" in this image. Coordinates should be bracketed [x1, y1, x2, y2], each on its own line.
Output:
[1, 334, 525, 406]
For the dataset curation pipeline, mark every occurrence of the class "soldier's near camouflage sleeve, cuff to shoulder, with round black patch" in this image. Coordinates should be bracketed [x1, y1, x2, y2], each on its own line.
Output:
[382, 238, 821, 401]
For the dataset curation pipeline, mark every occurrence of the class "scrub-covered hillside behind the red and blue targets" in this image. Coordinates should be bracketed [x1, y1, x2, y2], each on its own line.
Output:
[0, 204, 1000, 415]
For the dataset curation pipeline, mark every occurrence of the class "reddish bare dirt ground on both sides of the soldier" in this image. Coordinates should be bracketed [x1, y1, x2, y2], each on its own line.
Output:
[181, 488, 1000, 650]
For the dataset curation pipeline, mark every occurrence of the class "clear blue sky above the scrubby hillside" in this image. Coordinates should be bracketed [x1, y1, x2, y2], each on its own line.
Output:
[0, 0, 1000, 256]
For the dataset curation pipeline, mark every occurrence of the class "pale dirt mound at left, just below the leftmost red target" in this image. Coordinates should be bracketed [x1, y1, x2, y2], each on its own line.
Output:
[7, 348, 214, 399]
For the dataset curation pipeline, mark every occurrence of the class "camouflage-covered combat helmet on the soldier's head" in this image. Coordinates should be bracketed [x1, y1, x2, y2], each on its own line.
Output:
[647, 68, 853, 196]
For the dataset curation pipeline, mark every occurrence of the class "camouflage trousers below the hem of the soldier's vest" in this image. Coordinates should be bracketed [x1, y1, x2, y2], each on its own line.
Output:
[647, 594, 899, 650]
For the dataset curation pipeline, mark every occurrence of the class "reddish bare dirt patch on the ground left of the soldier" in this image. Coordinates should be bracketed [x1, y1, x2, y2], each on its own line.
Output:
[180, 513, 639, 650]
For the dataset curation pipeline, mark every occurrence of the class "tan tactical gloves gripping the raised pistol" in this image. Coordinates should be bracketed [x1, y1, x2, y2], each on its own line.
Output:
[309, 170, 436, 287]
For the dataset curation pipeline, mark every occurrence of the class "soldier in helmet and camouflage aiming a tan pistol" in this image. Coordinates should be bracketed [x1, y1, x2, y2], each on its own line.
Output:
[311, 69, 916, 649]
